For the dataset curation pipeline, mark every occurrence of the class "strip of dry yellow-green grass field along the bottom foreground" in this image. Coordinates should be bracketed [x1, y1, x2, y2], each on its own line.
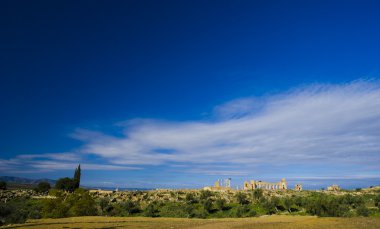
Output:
[2, 215, 380, 229]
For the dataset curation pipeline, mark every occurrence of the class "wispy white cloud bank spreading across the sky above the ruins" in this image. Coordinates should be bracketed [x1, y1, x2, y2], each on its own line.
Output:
[0, 81, 380, 179]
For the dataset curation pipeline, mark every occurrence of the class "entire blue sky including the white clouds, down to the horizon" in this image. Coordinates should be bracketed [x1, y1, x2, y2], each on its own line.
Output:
[0, 1, 380, 188]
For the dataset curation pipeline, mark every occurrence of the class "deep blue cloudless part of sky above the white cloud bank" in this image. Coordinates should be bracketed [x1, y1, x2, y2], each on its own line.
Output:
[0, 1, 380, 189]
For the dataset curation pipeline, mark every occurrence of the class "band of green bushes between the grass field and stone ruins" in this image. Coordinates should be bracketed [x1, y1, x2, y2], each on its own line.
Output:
[0, 188, 380, 224]
